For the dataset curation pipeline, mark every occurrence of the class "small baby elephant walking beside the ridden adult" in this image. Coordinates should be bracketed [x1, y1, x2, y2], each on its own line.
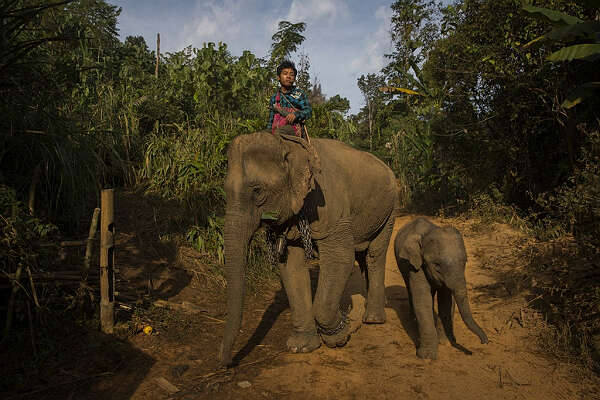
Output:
[394, 218, 488, 360]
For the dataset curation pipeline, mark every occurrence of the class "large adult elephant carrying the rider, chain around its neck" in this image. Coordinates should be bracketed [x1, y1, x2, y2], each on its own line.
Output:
[220, 132, 398, 365]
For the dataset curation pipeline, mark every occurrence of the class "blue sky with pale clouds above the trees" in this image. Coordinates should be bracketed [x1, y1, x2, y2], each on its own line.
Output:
[108, 0, 393, 113]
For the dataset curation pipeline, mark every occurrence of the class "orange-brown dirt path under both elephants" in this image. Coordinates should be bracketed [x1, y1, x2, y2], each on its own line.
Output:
[78, 211, 600, 400]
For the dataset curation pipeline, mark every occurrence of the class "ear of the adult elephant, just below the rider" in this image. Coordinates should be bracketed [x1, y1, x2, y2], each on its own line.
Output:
[281, 135, 321, 214]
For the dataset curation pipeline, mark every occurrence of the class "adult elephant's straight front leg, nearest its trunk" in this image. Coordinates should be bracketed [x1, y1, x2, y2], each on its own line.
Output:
[280, 246, 321, 353]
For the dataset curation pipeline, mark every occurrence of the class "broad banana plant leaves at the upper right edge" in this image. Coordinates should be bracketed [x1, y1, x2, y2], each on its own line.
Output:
[523, 0, 600, 109]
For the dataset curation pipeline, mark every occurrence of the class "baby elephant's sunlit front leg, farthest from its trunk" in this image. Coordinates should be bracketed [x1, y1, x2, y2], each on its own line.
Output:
[409, 270, 438, 360]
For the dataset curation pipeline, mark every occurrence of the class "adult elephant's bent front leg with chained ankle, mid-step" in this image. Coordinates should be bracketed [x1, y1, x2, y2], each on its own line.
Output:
[313, 220, 355, 347]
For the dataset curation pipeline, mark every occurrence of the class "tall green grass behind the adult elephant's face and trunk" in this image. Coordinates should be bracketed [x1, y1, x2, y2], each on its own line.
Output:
[136, 112, 273, 283]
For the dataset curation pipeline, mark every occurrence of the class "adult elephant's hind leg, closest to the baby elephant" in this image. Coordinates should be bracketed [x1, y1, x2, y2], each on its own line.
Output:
[363, 218, 394, 324]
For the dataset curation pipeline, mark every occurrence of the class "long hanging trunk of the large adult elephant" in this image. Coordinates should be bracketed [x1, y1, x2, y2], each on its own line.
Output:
[220, 210, 258, 367]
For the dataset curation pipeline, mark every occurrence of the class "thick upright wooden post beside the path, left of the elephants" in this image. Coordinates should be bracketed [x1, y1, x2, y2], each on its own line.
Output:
[100, 189, 115, 333]
